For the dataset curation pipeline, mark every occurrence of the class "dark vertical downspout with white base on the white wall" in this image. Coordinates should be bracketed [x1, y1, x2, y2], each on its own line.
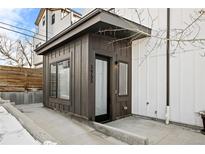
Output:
[165, 8, 170, 125]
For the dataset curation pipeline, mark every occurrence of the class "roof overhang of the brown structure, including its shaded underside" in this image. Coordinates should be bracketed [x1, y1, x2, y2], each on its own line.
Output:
[35, 9, 151, 55]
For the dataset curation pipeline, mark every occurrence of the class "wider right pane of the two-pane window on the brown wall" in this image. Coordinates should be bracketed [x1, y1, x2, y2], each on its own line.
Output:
[58, 60, 70, 99]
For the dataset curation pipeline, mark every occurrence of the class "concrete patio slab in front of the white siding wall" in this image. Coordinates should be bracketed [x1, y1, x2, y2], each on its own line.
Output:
[106, 116, 205, 145]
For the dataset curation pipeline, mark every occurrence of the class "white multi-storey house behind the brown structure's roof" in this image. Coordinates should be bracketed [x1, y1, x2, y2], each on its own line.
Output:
[33, 8, 81, 67]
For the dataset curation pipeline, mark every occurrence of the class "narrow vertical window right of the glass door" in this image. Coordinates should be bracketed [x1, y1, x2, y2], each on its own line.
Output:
[119, 62, 128, 95]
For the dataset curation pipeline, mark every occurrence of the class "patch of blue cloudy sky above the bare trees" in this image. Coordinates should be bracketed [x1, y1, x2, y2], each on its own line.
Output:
[0, 8, 83, 40]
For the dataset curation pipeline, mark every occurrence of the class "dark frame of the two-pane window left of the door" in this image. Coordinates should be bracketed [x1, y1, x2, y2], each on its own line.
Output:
[49, 58, 72, 101]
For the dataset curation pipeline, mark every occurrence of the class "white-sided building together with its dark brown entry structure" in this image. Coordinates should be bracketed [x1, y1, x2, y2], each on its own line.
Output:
[36, 9, 205, 126]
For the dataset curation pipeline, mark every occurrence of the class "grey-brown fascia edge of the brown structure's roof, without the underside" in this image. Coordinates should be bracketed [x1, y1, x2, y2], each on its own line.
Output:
[34, 9, 151, 55]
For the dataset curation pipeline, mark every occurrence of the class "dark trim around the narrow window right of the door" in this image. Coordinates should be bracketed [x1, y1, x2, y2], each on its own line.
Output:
[117, 60, 129, 97]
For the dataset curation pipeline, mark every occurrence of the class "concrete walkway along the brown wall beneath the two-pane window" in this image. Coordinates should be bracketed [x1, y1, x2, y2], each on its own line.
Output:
[16, 104, 125, 145]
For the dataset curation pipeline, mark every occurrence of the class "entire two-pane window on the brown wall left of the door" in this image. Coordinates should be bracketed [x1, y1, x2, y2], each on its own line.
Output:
[50, 60, 70, 100]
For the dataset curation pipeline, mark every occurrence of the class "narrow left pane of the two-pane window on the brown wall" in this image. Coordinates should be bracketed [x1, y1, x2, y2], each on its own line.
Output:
[50, 64, 56, 97]
